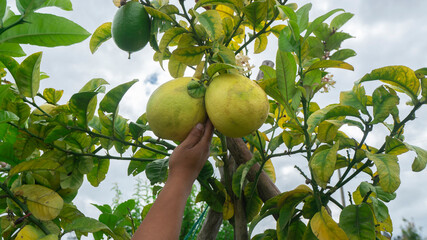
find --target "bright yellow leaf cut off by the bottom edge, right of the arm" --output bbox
[310,206,348,240]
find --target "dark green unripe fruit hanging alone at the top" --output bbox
[111,1,151,53]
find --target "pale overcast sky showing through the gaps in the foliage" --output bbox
[8,0,427,237]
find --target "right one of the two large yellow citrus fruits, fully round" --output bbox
[205,74,269,137]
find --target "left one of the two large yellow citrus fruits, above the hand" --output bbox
[146,77,207,141]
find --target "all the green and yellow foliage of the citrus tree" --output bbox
[0,0,427,240]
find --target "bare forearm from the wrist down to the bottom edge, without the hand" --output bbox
[132,176,194,240]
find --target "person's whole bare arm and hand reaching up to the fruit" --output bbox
[132,120,213,240]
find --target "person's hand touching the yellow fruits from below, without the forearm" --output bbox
[168,120,214,184]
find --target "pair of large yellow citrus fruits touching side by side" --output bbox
[146,74,269,141]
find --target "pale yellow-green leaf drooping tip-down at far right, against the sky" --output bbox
[365,151,400,193]
